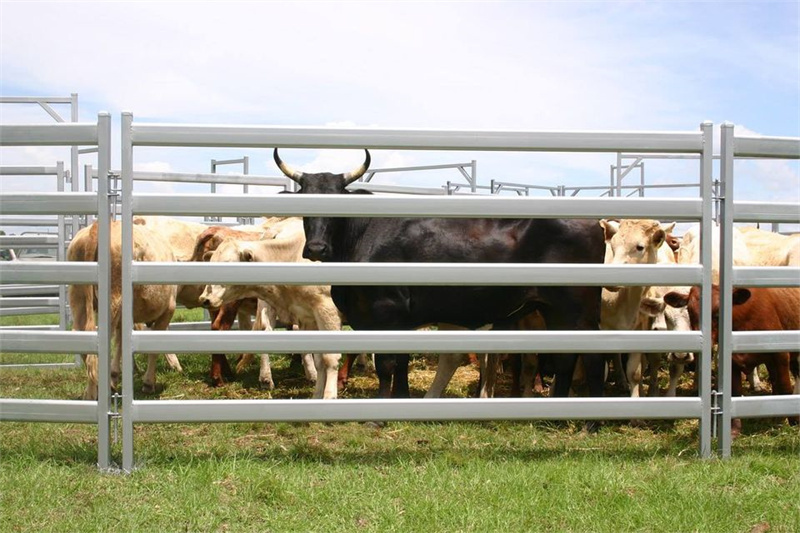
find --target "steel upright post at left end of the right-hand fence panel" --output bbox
[717,123,741,458]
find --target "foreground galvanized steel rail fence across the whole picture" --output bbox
[0,113,800,470]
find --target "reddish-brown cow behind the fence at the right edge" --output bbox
[664,285,800,435]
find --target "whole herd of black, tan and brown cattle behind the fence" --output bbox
[67,149,800,432]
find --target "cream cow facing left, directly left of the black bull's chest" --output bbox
[201,238,342,399]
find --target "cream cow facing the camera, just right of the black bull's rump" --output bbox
[600,219,675,397]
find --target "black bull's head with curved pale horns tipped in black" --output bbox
[273,148,370,261]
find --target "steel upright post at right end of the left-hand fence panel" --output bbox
[95,113,112,469]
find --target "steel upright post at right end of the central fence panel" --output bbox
[697,122,714,458]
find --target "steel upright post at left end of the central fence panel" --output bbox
[119,112,133,472]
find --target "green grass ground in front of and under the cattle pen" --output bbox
[0,315,800,533]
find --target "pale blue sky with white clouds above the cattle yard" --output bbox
[0,0,800,218]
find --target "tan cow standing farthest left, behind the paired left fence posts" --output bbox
[67,221,177,400]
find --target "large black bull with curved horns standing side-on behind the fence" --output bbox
[274,148,605,398]
